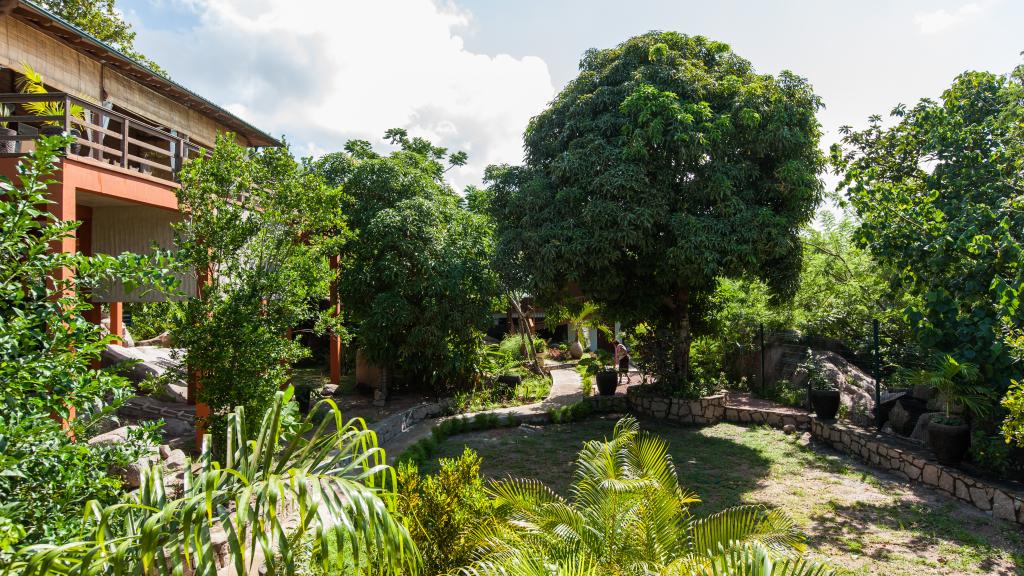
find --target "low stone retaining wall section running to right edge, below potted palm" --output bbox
[811,419,1024,524]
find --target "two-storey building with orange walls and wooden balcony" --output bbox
[0,0,296,412]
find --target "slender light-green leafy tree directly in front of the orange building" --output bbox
[173,135,344,445]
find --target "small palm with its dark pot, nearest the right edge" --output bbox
[911,355,988,465]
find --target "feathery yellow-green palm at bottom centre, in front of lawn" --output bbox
[463,417,831,576]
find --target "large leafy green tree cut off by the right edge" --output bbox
[834,67,1024,430]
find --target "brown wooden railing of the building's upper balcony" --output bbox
[0,92,206,181]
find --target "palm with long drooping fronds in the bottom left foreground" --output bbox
[5,393,419,576]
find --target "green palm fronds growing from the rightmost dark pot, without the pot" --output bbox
[909,355,990,423]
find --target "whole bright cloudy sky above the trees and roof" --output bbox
[118,0,1024,190]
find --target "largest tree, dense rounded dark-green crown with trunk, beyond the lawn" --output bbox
[489,32,822,381]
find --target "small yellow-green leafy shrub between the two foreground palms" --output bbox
[397,448,494,574]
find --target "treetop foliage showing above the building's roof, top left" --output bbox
[38,0,167,76]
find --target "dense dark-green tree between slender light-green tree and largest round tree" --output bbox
[341,129,498,387]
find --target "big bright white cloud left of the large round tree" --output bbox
[139,0,554,189]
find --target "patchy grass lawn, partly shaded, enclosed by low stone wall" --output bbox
[419,418,1024,576]
